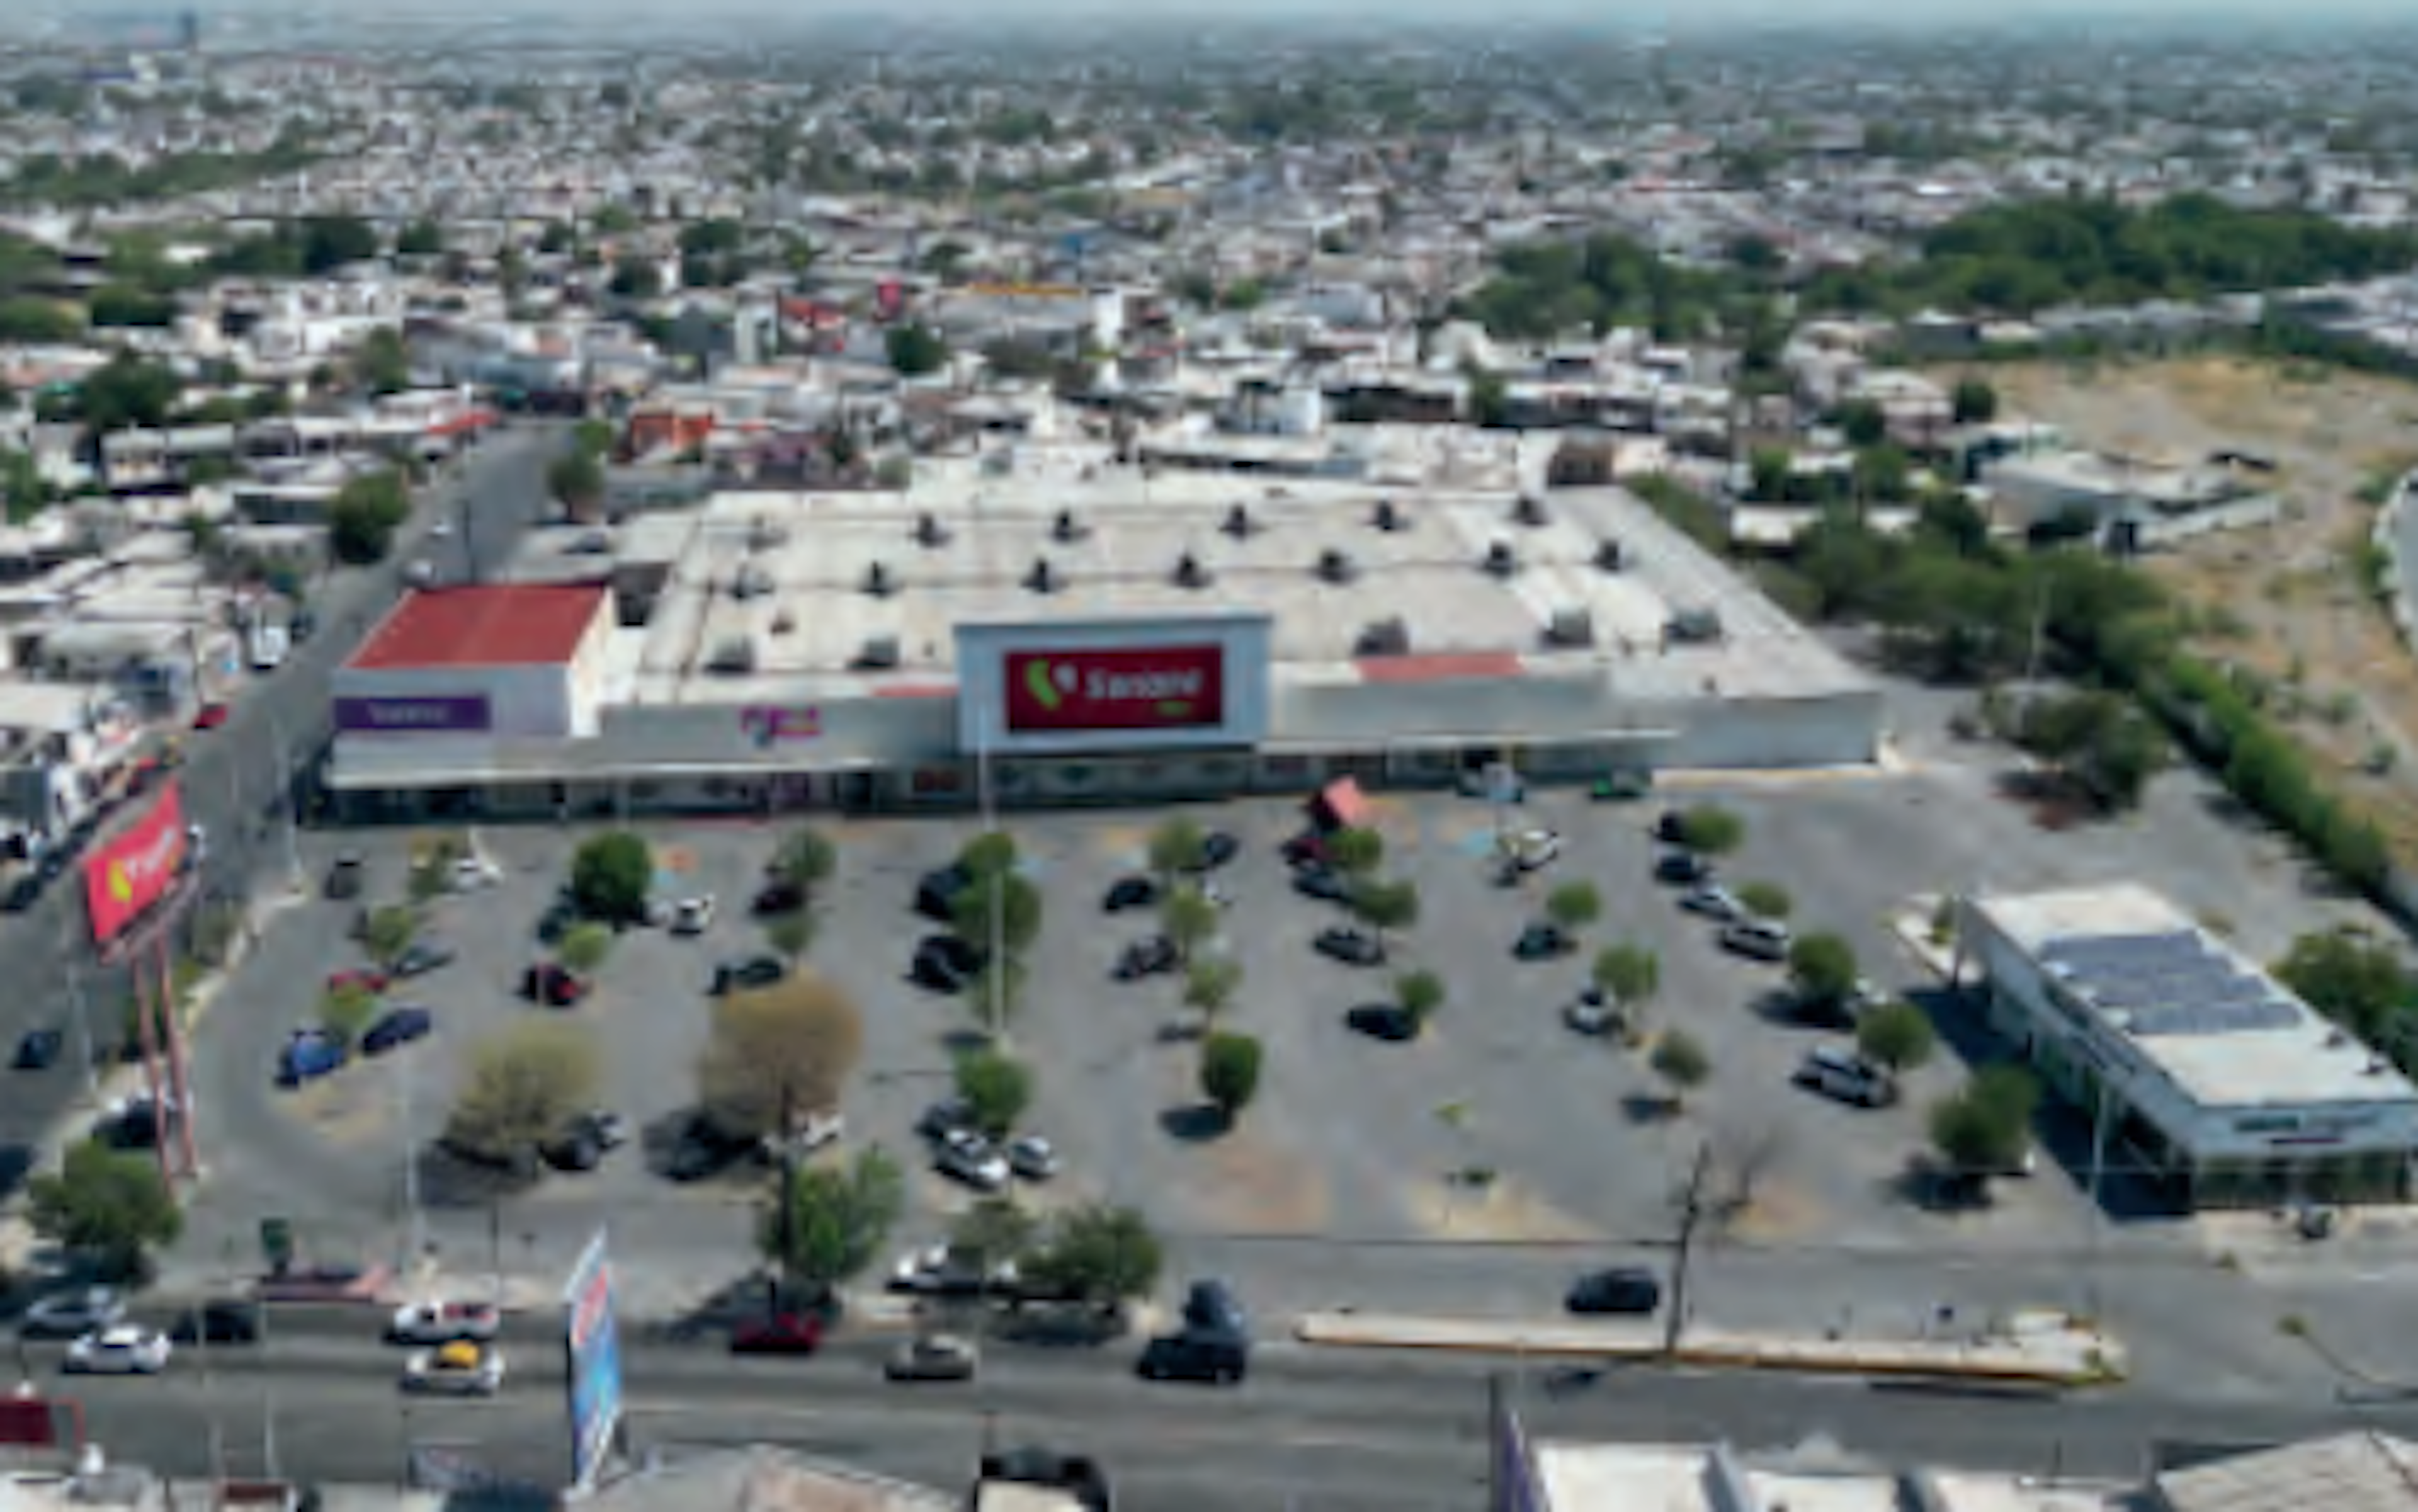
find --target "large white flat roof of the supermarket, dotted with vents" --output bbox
[594,467,1866,704]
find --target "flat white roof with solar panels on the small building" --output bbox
[1973,883,2418,1108]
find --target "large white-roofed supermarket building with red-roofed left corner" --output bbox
[326,462,1882,817]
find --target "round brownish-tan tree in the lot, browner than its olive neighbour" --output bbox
[696,972,866,1139]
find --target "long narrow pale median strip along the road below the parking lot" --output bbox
[1293,1311,2125,1386]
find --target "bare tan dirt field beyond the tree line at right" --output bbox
[1980,356,2418,863]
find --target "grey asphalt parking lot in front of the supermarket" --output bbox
[146,702,2336,1335]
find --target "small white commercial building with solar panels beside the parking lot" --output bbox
[1956,883,2418,1207]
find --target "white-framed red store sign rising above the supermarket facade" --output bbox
[958,610,1269,759]
